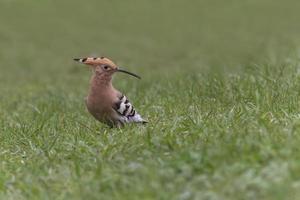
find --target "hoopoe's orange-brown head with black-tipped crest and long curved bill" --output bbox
[74,57,141,79]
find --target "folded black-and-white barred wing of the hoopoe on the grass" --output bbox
[113,94,147,123]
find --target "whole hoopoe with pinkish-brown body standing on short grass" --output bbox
[74,57,147,127]
